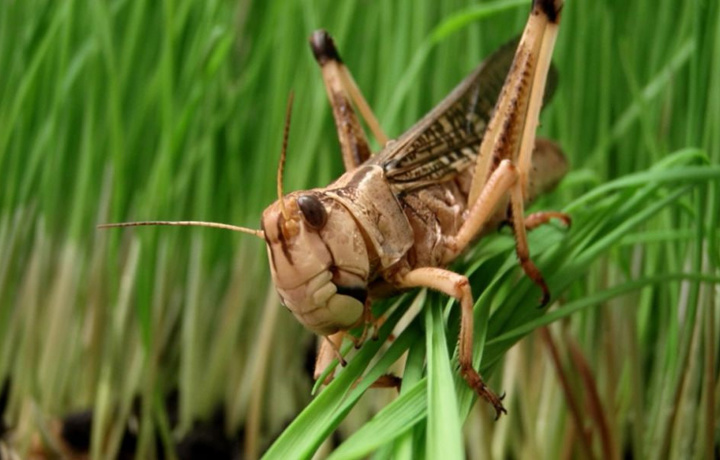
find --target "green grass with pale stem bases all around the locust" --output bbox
[0,0,720,458]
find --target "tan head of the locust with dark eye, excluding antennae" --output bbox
[262,191,369,335]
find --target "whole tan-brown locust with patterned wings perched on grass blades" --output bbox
[101,0,570,418]
